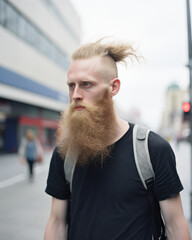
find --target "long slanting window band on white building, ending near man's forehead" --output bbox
[0,0,68,69]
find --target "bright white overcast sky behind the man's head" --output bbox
[71,0,189,130]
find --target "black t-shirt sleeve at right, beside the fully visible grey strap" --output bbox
[149,132,183,201]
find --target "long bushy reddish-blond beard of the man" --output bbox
[58,90,115,165]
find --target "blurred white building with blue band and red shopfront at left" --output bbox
[0,0,81,152]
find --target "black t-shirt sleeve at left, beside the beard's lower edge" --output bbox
[45,148,70,200]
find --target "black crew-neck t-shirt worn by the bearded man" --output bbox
[46,124,183,240]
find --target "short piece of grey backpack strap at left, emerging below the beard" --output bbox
[64,151,77,192]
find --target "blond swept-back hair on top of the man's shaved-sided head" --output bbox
[72,38,138,63]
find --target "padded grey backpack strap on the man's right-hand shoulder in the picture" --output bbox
[133,125,155,190]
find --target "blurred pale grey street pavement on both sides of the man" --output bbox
[0,142,192,240]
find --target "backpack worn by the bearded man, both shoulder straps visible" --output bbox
[64,125,167,240]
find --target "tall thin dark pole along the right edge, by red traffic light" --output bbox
[186,0,192,222]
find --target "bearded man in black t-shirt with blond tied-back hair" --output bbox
[44,40,191,240]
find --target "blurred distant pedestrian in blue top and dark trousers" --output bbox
[19,129,43,180]
